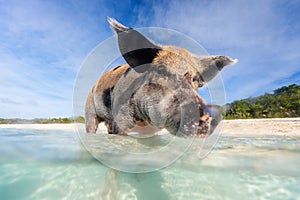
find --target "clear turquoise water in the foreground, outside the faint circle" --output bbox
[0,129,300,200]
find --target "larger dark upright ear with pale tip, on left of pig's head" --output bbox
[107,18,161,70]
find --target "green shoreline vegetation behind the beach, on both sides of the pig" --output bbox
[0,84,300,124]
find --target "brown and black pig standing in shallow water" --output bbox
[85,18,237,136]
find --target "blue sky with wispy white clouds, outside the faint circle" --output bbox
[0,0,300,118]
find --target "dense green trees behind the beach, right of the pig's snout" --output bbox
[225,84,300,119]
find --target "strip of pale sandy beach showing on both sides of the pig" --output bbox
[0,118,300,136]
